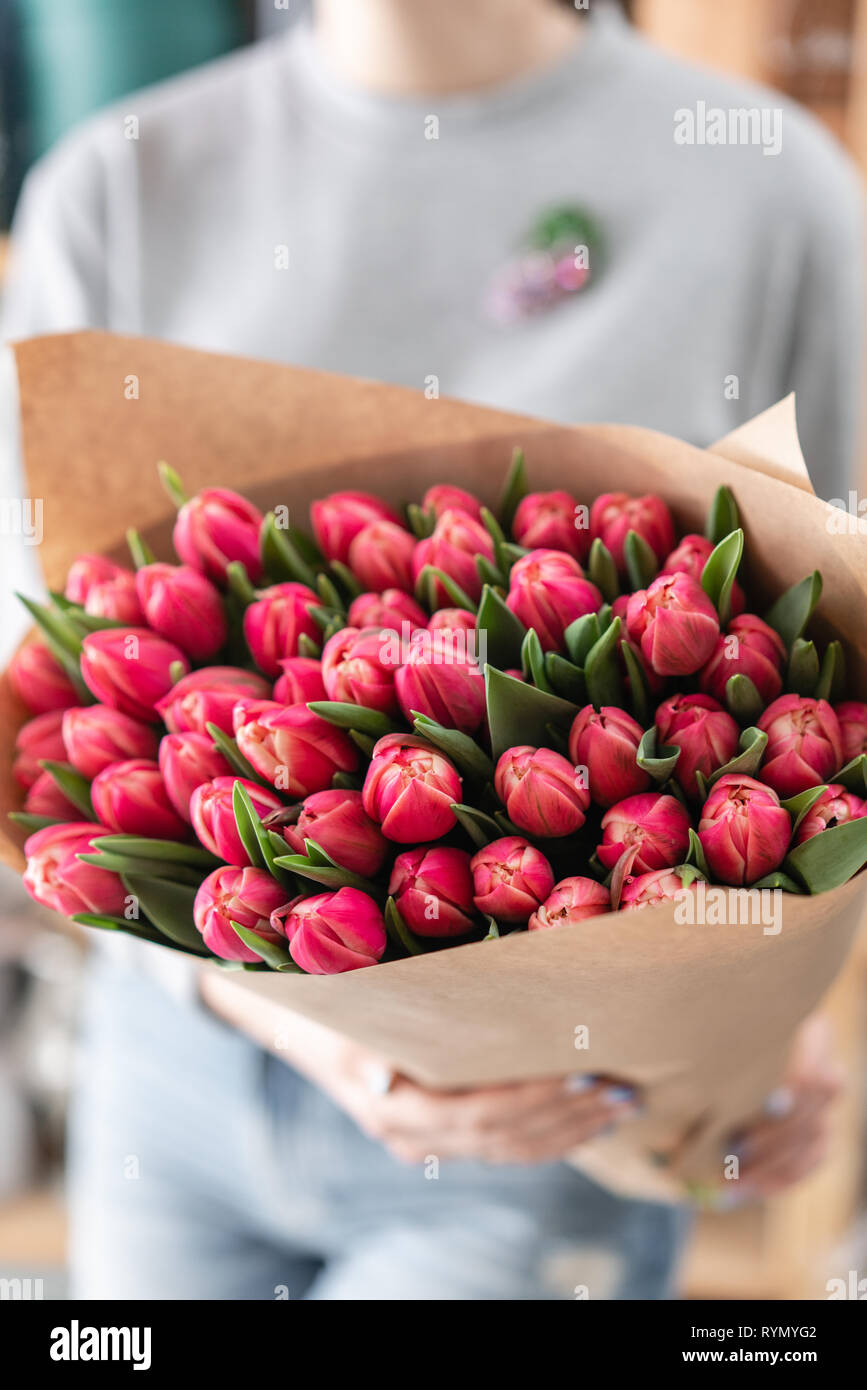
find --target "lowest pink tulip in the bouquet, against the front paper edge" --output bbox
[271,888,386,974]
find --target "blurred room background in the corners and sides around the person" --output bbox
[0,0,867,1298]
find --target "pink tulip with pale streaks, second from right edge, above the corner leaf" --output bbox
[759,695,843,796]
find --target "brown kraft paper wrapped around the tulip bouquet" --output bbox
[0,334,867,1200]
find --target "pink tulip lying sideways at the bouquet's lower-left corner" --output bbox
[24,820,126,917]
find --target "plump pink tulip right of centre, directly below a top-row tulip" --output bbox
[506,550,602,652]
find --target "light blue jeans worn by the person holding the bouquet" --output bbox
[69,962,688,1300]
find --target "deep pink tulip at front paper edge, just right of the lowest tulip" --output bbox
[389,845,475,937]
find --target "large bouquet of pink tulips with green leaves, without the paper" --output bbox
[10,455,867,974]
